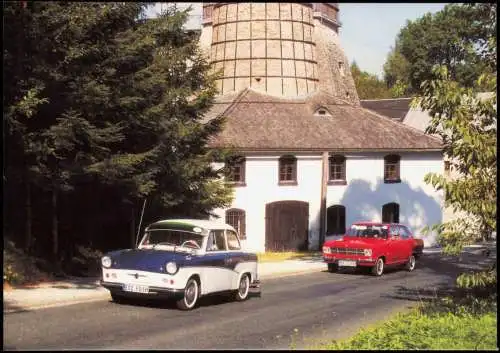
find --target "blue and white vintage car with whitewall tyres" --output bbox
[101,219,260,310]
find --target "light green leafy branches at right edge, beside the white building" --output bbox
[414,67,497,253]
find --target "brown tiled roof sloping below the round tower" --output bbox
[207,88,442,151]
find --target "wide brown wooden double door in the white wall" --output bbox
[266,201,309,251]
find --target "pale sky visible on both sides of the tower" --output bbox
[148,2,446,78]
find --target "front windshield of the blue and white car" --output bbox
[141,229,203,250]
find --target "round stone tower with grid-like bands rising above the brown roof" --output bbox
[200,3,359,105]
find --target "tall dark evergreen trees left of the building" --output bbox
[4,2,231,262]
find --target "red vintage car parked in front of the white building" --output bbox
[323,222,424,276]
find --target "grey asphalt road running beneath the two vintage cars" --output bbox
[4,255,494,350]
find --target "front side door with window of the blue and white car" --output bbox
[202,230,232,293]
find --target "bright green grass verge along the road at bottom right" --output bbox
[315,294,497,350]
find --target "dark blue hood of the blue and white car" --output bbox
[107,249,190,272]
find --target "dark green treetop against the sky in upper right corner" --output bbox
[384,3,496,94]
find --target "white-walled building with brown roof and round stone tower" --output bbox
[200,3,443,251]
